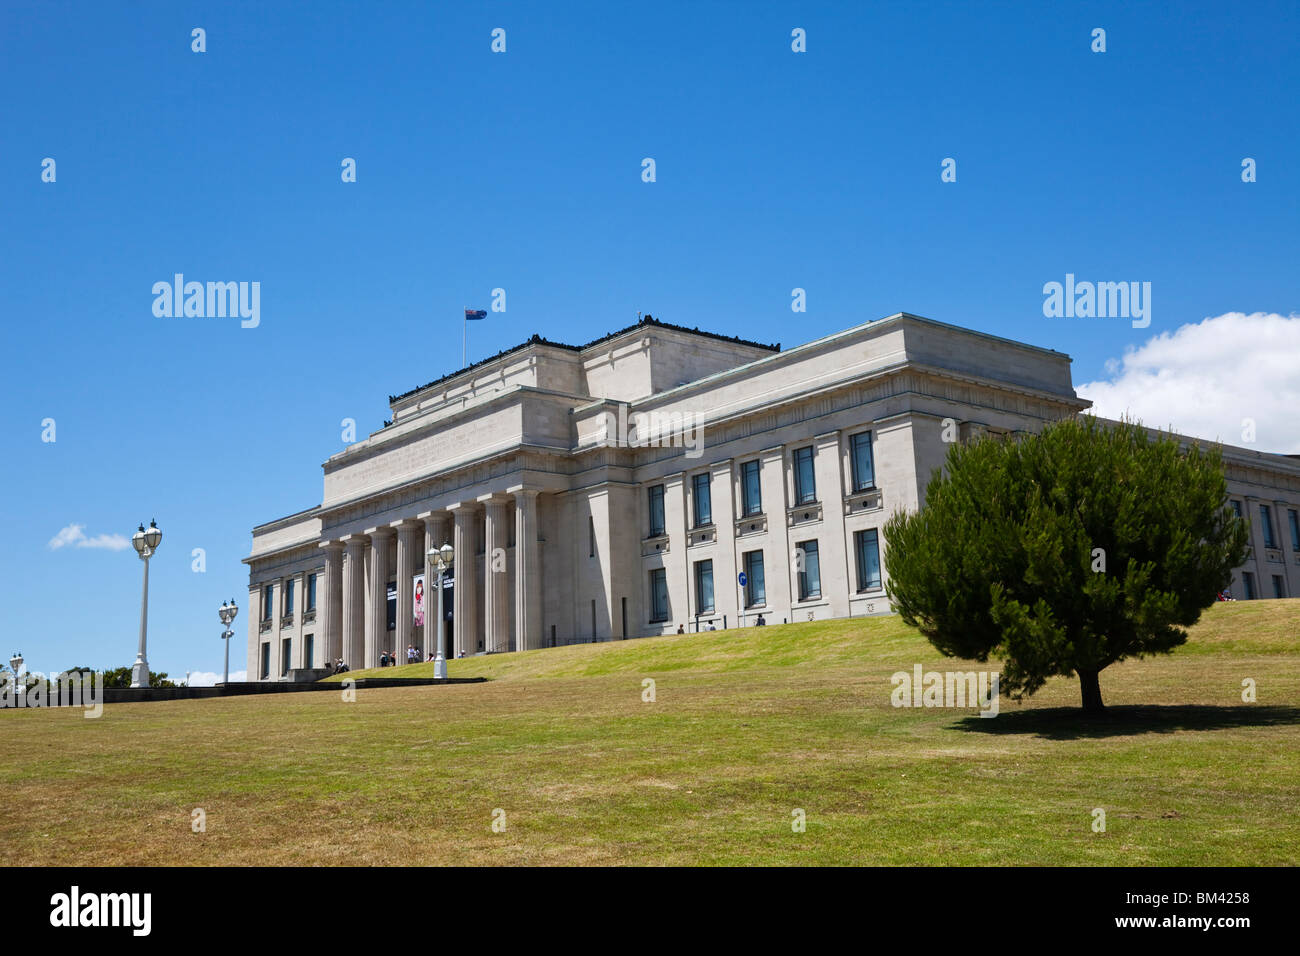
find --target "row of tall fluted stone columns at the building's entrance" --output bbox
[321,486,542,670]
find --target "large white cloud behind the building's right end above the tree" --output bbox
[1076,312,1300,454]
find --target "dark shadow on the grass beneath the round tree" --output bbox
[956,701,1300,740]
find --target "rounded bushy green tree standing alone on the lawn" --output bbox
[884,416,1249,713]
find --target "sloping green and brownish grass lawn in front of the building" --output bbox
[0,601,1300,865]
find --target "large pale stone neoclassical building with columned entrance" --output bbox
[246,313,1300,680]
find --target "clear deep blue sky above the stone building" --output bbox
[0,0,1300,676]
